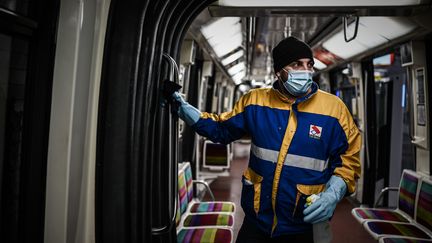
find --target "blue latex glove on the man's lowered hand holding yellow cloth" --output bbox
[303,175,347,224]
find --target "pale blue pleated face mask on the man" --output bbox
[283,69,313,97]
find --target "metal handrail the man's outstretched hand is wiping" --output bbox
[152,53,179,235]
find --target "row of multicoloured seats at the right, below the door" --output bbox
[351,170,432,243]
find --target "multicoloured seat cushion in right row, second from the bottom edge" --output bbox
[364,221,430,239]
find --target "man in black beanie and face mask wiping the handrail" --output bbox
[169,37,361,242]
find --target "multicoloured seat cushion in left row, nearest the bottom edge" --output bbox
[177,228,233,243]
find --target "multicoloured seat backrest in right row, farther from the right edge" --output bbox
[398,170,420,218]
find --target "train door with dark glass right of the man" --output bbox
[363,45,424,206]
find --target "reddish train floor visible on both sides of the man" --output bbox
[204,143,376,243]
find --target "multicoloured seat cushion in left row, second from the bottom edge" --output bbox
[183,214,234,227]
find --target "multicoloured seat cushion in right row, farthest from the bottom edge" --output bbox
[352,208,409,223]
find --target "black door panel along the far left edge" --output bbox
[0,0,59,242]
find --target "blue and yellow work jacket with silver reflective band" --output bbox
[192,82,361,237]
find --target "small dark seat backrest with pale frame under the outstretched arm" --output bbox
[203,140,230,169]
